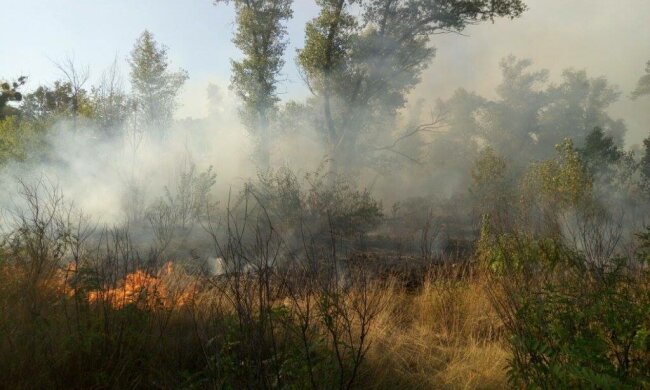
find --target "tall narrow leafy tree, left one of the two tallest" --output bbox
[215,0,293,169]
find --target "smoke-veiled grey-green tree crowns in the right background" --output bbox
[431,56,626,171]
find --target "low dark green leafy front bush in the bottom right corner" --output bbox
[498,258,650,389]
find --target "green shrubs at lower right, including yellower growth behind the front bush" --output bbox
[478,221,650,389]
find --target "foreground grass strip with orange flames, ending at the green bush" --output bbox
[0,254,508,389]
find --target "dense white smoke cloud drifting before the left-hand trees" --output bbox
[0,84,255,225]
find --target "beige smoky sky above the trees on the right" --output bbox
[411,0,650,146]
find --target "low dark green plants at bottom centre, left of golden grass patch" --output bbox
[183,307,338,390]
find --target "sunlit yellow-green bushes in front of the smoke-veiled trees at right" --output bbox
[470,139,599,244]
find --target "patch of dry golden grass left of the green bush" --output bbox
[364,275,508,389]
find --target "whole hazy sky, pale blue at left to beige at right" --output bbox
[0,0,650,144]
